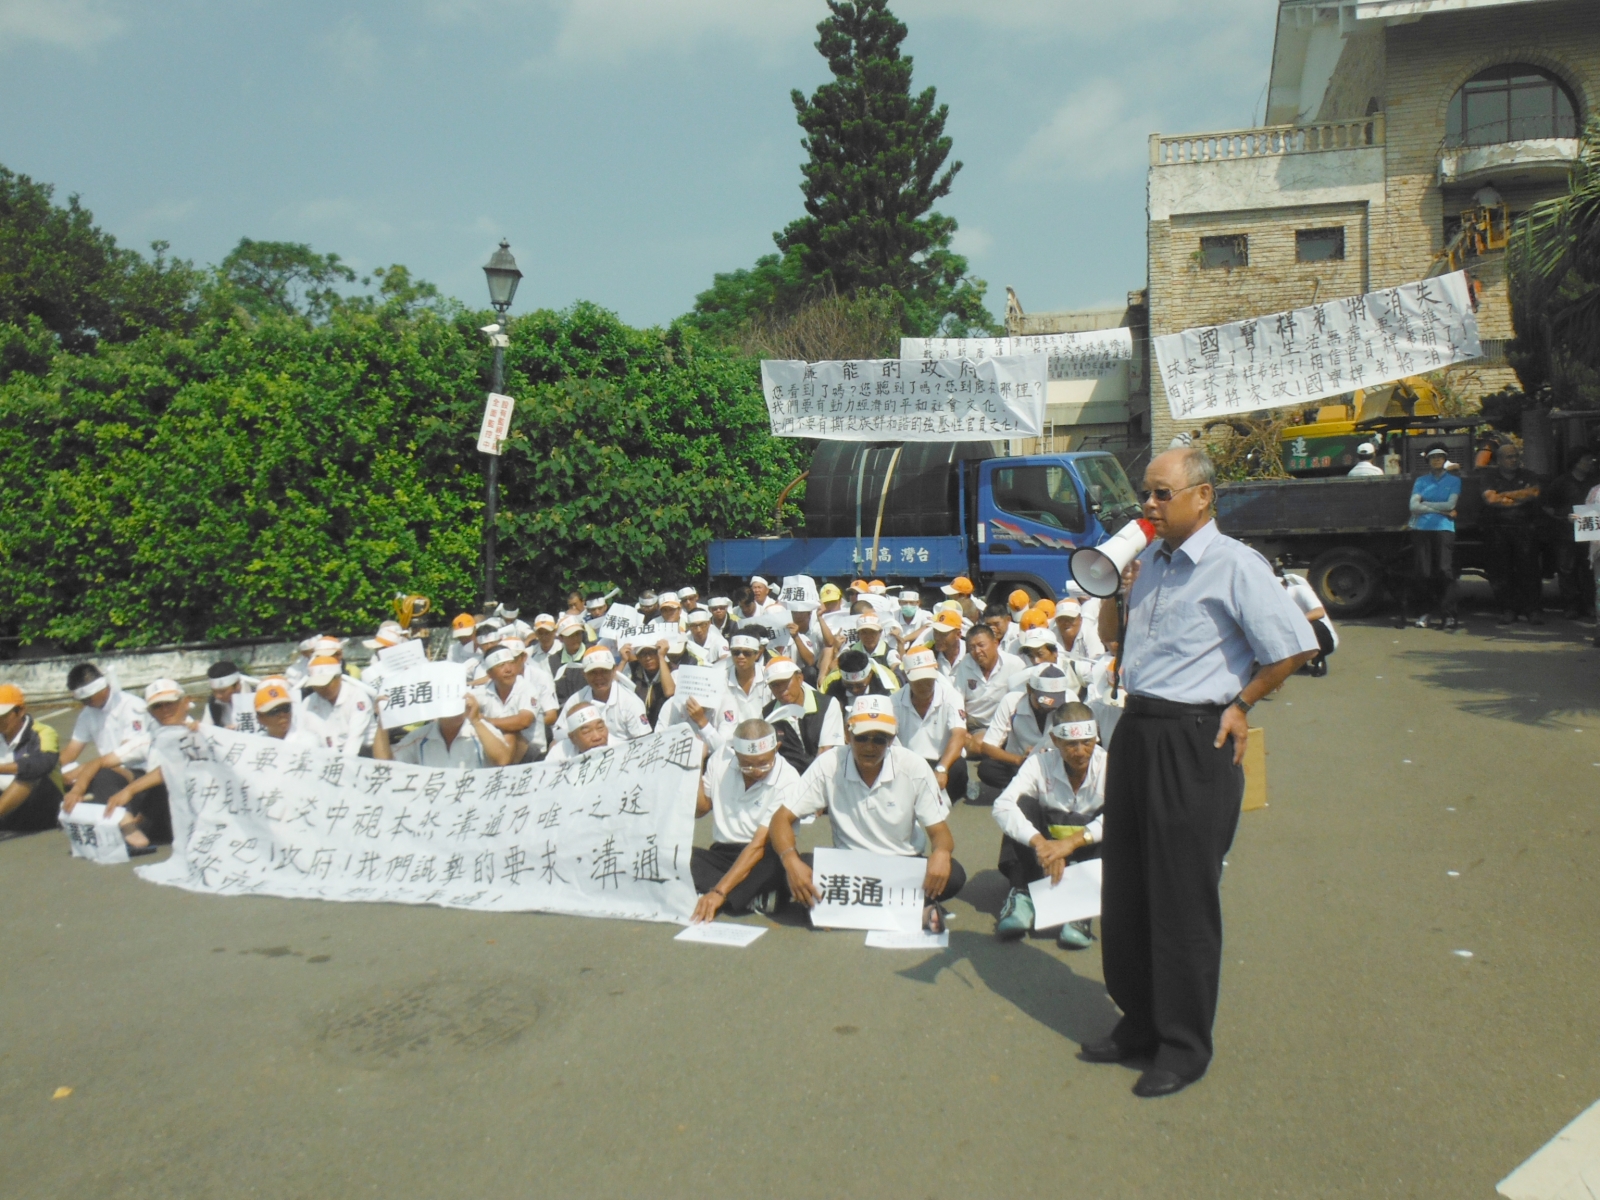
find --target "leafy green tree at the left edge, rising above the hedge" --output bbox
[0,166,200,352]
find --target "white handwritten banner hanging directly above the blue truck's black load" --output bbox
[762,355,1046,442]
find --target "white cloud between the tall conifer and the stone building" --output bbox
[1011,78,1160,179]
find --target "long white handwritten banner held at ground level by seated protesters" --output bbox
[139,725,699,925]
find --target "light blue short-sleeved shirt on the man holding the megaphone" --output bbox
[1122,520,1317,704]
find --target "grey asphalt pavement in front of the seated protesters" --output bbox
[0,618,1600,1200]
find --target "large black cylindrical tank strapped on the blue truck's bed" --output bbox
[805,442,997,538]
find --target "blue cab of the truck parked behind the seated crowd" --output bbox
[973,451,1139,595]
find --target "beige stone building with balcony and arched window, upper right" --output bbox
[1147,0,1600,451]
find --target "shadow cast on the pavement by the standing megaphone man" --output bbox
[896,930,1117,1042]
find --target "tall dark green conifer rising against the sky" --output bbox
[691,0,994,341]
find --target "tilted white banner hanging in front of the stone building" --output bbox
[1155,270,1483,421]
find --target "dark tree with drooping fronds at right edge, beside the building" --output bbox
[1507,118,1600,408]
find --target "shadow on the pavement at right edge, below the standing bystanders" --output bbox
[1395,649,1600,725]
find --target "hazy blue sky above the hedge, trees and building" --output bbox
[0,0,1275,325]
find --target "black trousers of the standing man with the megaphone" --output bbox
[1101,696,1245,1078]
